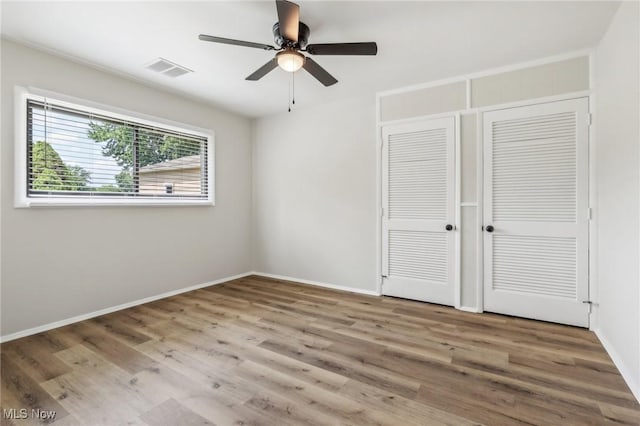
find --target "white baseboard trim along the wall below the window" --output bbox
[0,272,253,343]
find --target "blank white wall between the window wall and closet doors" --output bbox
[253,95,377,291]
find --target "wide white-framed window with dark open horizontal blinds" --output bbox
[16,87,213,207]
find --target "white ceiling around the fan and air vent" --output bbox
[1,1,619,117]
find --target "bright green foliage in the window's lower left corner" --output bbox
[31,141,91,191]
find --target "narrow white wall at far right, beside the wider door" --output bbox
[594,2,640,399]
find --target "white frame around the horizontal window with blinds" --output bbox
[14,86,215,208]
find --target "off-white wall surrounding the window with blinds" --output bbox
[1,40,251,336]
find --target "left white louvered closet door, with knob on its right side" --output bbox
[382,117,455,305]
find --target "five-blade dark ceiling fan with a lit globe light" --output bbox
[198,0,378,86]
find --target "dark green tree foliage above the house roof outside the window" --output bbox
[88,123,200,171]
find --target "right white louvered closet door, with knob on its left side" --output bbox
[483,98,589,327]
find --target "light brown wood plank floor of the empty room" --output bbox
[0,277,640,426]
